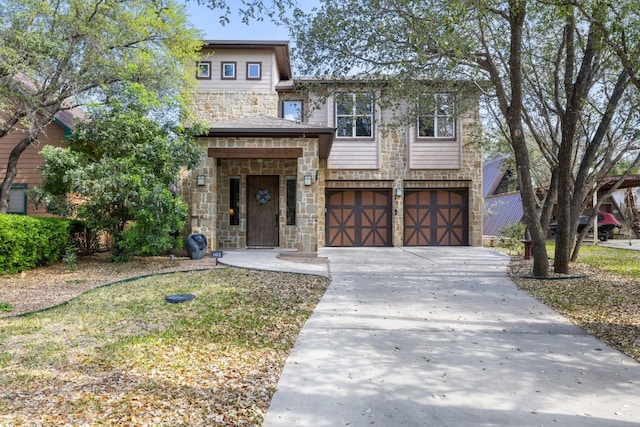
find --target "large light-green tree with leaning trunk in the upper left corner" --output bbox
[0,0,201,213]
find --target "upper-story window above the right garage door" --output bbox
[418,94,456,139]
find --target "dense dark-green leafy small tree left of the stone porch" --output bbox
[34,85,201,260]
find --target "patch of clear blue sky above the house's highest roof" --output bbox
[187,0,296,40]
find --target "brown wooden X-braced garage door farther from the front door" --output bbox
[404,189,469,246]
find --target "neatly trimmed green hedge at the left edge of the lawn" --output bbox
[0,215,70,274]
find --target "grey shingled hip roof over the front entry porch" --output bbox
[203,116,336,159]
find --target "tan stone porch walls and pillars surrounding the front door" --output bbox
[191,138,320,252]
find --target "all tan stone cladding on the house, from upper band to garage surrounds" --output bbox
[188,91,483,252]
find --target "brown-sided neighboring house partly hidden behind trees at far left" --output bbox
[0,110,80,216]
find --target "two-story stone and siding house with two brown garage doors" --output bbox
[188,41,483,253]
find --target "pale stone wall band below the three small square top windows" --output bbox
[195,91,279,123]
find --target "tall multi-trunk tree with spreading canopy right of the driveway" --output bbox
[292,0,635,276]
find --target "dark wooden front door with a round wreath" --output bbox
[247,175,280,247]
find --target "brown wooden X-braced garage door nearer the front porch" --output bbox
[325,190,391,247]
